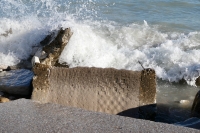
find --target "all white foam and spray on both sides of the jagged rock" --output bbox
[0,0,200,85]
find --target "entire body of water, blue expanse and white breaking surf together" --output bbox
[0,0,200,123]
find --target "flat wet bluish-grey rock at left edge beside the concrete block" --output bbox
[0,69,34,95]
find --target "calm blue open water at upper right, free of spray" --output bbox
[94,0,200,32]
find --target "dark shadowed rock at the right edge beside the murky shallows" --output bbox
[191,91,200,118]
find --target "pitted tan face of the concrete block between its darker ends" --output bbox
[32,67,141,114]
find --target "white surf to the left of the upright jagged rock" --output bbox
[0,17,45,65]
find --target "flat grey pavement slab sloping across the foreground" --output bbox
[0,99,199,133]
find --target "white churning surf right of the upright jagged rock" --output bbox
[60,21,200,85]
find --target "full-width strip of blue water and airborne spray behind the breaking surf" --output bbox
[0,0,200,32]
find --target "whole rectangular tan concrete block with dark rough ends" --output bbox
[32,64,156,117]
